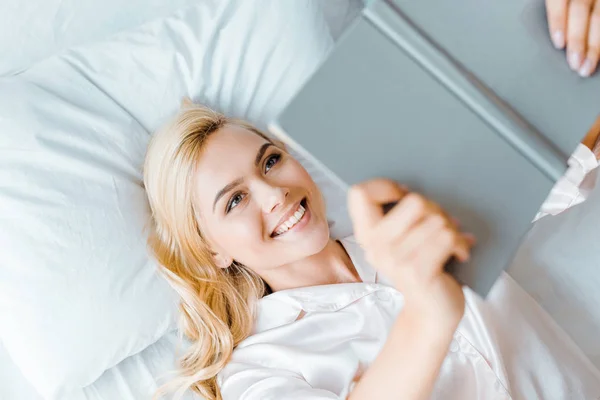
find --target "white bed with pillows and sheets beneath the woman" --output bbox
[0,0,600,400]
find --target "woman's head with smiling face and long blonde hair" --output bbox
[144,104,336,398]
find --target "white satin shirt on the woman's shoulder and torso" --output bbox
[218,238,600,400]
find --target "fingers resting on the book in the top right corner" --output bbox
[546,0,600,77]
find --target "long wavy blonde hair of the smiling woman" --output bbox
[144,101,270,400]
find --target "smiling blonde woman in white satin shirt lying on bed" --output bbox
[144,105,600,400]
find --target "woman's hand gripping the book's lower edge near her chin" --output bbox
[348,179,473,325]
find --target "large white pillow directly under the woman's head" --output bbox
[0,0,343,399]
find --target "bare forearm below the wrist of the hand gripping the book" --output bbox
[348,307,458,400]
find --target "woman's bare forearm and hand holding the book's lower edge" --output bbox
[348,179,473,400]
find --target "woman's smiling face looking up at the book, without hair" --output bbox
[195,125,329,275]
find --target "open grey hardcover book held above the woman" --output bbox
[270,0,600,296]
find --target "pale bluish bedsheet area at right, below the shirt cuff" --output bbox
[508,169,600,368]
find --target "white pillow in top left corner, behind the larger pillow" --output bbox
[0,0,197,76]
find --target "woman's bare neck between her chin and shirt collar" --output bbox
[262,239,361,292]
